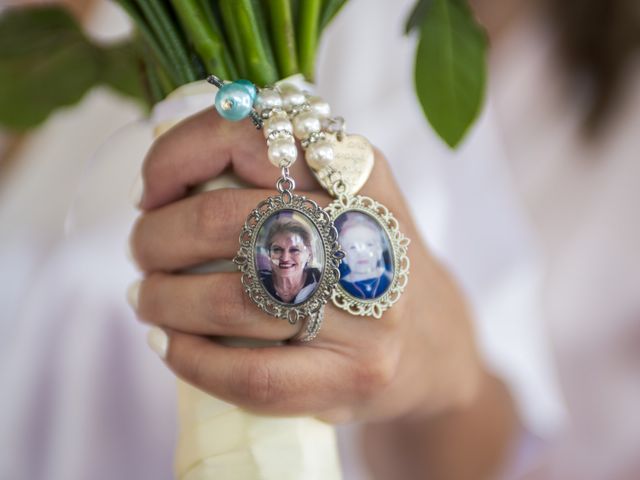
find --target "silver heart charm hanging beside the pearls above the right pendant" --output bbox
[312,135,374,196]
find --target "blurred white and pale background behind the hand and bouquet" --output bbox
[0,0,640,480]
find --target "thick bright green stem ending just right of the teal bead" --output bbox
[221,0,278,86]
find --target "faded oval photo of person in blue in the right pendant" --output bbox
[335,212,393,300]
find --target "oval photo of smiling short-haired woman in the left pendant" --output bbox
[256,210,324,305]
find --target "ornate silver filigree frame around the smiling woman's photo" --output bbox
[233,190,343,326]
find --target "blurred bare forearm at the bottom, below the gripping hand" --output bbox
[362,374,519,480]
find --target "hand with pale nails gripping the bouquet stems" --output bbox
[131,109,482,422]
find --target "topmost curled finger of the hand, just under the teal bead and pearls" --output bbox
[140,108,318,210]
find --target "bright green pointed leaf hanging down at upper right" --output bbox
[414,0,487,147]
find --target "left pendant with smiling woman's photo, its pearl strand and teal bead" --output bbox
[208,76,344,342]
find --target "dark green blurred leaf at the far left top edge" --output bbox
[0,7,101,130]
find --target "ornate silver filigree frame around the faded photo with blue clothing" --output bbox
[325,195,410,318]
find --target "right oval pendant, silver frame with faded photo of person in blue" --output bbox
[326,195,410,318]
